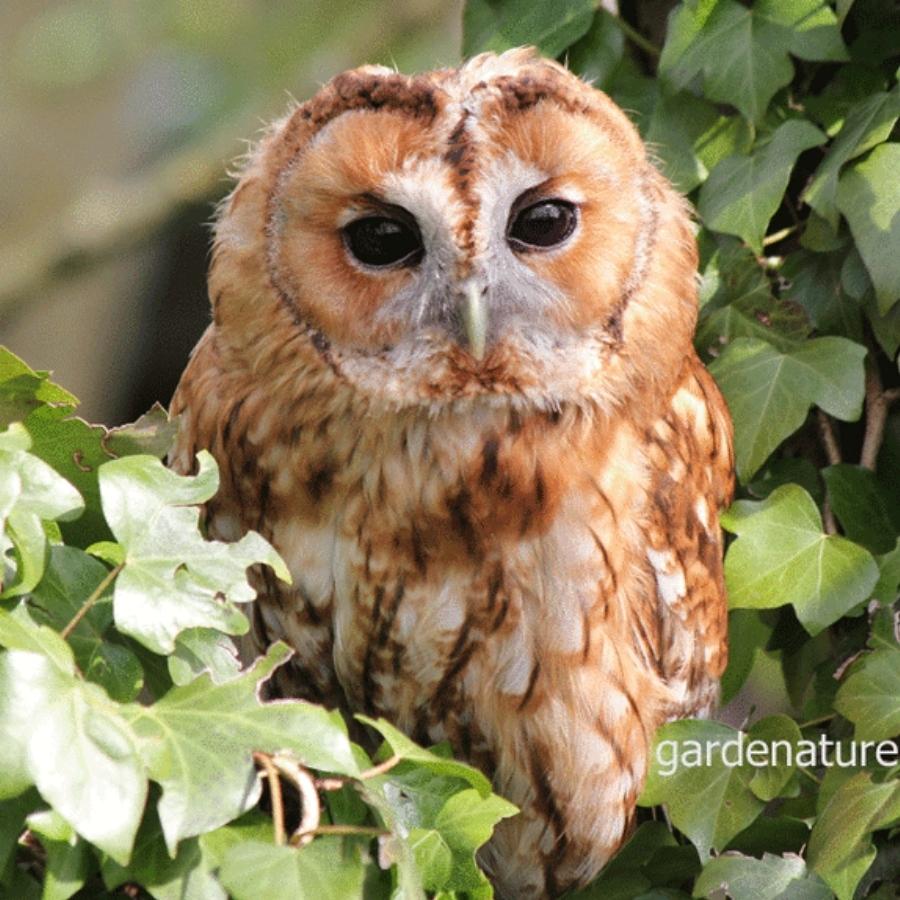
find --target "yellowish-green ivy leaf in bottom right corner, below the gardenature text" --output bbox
[807,772,900,900]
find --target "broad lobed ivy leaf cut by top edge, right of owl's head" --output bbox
[659,0,847,121]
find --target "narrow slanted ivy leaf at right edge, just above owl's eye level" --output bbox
[801,87,900,229]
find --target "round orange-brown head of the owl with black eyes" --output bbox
[210,49,696,410]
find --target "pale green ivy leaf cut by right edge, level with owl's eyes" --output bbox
[837,144,900,315]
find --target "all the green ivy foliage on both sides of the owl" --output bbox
[0,0,900,900]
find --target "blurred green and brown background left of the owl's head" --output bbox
[0,0,462,424]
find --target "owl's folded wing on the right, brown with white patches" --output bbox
[646,357,734,717]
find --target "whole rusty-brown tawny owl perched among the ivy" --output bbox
[174,50,732,898]
